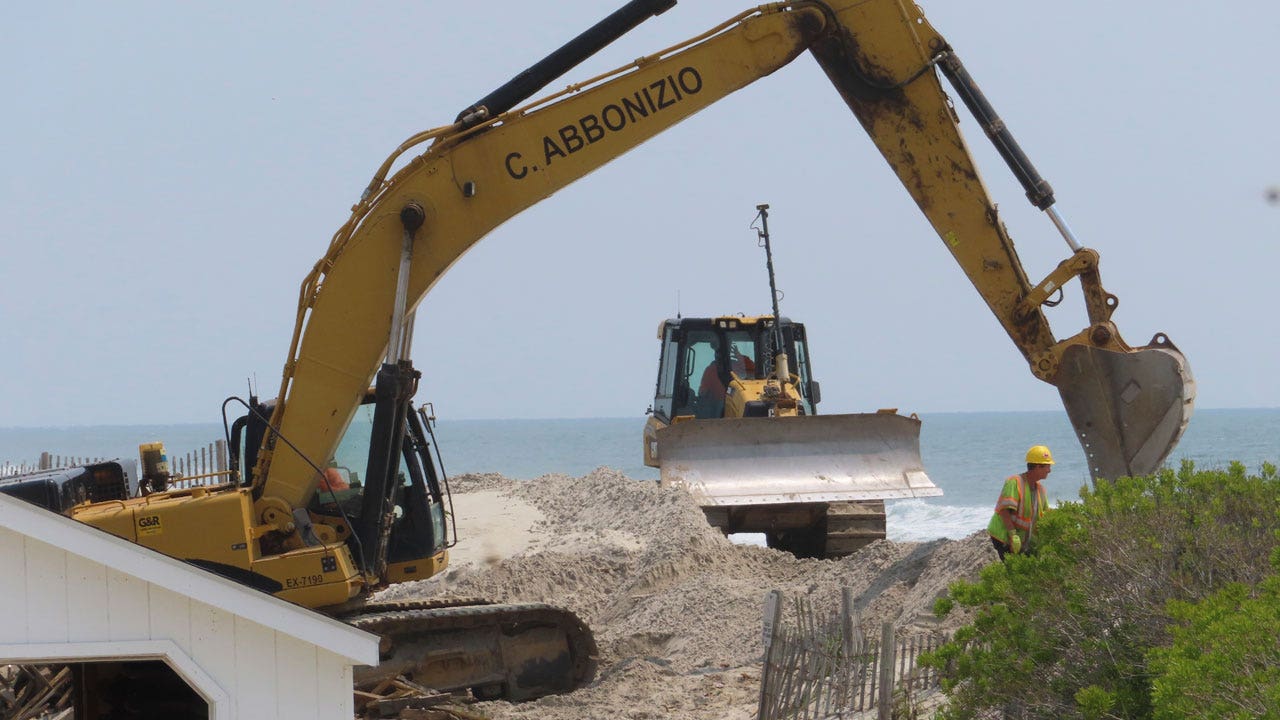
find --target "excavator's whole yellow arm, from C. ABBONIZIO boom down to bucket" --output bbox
[255,0,1193,507]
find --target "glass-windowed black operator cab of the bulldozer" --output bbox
[653,316,819,423]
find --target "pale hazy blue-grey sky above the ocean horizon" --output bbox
[0,0,1280,427]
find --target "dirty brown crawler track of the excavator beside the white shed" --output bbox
[334,598,599,702]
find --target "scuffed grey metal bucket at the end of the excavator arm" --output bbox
[1055,334,1196,482]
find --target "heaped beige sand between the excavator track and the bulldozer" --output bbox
[373,468,995,720]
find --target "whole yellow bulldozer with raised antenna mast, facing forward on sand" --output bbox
[644,204,942,559]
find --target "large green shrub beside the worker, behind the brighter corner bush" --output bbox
[927,462,1280,720]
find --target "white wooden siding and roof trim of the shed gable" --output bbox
[0,496,378,720]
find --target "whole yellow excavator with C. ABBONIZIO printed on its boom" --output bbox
[40,0,1193,700]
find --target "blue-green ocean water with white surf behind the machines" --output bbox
[0,409,1280,541]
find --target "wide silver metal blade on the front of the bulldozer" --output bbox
[657,413,942,507]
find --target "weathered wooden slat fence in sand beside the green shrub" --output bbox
[758,591,946,720]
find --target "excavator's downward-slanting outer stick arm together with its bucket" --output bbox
[812,1,1196,479]
